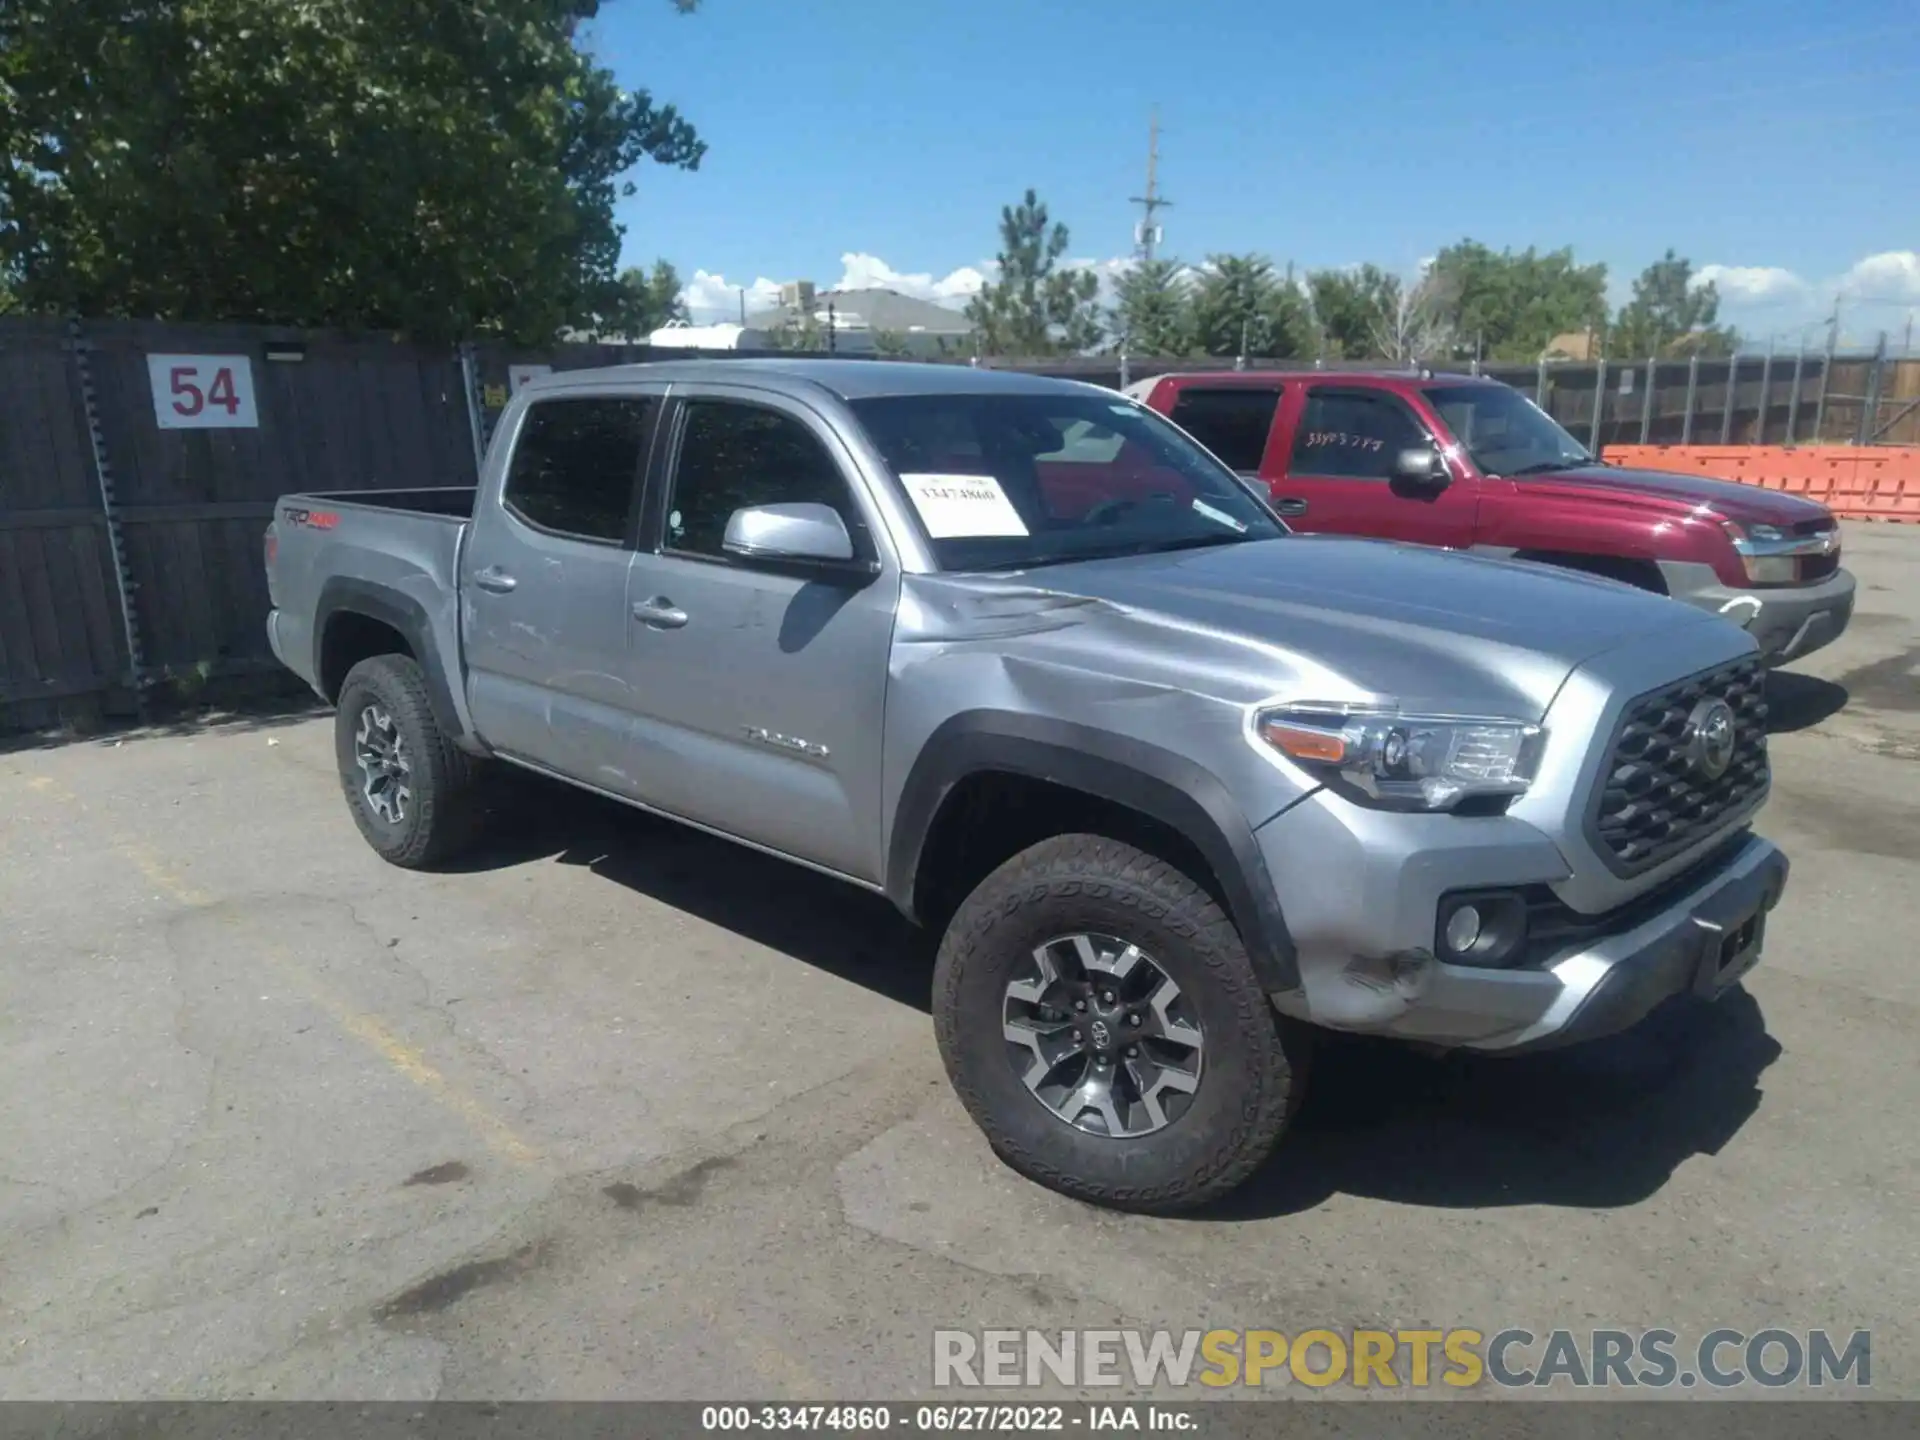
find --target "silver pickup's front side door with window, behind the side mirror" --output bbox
[626,382,900,881]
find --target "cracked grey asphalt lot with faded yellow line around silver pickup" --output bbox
[0,526,1920,1400]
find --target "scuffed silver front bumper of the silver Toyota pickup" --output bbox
[1260,801,1788,1052]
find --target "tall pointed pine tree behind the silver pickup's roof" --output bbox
[966,190,1100,355]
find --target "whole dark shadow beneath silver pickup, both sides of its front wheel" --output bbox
[449,778,1780,1223]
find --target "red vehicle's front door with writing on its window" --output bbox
[1269,382,1478,549]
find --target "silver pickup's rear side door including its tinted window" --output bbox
[459,384,664,795]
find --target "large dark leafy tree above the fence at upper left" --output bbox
[0,0,705,340]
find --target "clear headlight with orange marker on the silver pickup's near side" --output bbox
[1254,703,1546,810]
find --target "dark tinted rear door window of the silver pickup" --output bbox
[501,396,657,545]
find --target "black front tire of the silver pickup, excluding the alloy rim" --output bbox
[933,835,1304,1213]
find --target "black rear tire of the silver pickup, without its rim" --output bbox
[334,655,482,870]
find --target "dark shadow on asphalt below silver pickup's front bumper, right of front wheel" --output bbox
[1196,987,1780,1221]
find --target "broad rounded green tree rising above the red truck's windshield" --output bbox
[1427,240,1607,359]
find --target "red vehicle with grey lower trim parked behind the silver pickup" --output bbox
[1127,371,1853,664]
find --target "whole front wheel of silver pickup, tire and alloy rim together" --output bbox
[933,835,1296,1213]
